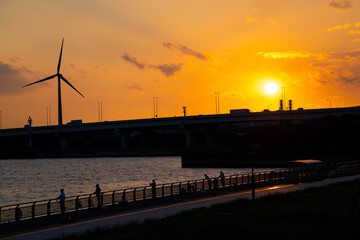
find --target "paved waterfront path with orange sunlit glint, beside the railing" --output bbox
[4,174,360,240]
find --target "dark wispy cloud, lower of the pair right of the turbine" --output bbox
[122,52,183,77]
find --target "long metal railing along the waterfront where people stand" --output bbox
[0,162,360,224]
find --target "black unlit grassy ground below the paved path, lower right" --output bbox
[54,180,360,240]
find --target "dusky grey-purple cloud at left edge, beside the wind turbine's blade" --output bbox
[0,61,34,94]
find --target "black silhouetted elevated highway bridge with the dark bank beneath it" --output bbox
[0,107,360,167]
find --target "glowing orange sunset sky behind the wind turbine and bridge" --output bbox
[0,0,360,128]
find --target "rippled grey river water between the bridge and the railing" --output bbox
[0,157,278,206]
